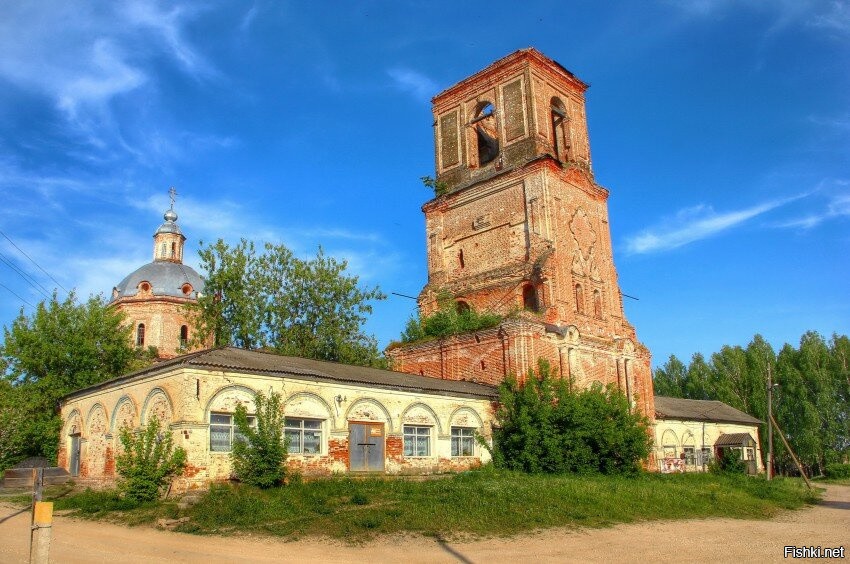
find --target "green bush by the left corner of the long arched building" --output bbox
[115,417,186,503]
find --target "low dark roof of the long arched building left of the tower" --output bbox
[63,347,498,400]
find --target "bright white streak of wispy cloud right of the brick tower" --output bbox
[626,195,804,254]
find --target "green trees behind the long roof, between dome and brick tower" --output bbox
[188,239,385,365]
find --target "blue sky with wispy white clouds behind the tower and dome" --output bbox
[0,0,850,366]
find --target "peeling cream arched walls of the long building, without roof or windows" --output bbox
[59,368,492,492]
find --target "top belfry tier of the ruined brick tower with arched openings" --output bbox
[432,48,591,198]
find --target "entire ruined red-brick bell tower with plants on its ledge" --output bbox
[387,49,653,417]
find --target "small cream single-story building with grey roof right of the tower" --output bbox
[653,396,764,474]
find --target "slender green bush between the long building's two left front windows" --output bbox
[230,392,286,488]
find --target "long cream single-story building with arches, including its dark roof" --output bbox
[59,347,497,492]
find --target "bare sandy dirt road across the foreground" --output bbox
[0,486,850,564]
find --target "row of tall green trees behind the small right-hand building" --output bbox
[654,331,850,474]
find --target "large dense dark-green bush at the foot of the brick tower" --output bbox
[493,361,651,474]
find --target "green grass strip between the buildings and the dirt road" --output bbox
[34,470,817,541]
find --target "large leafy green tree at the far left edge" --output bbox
[0,292,155,464]
